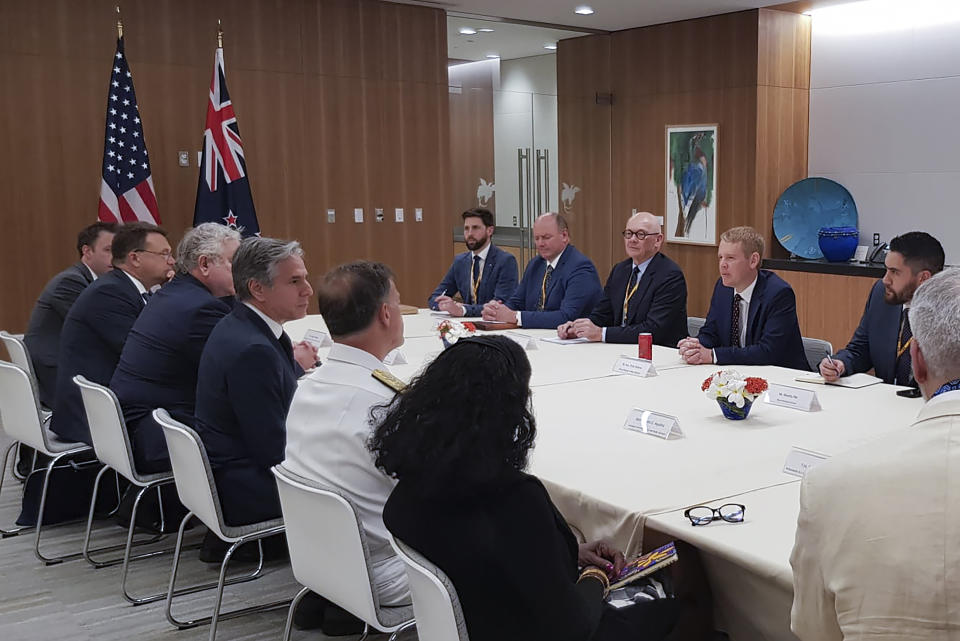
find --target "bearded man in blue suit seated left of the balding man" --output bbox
[427,208,517,316]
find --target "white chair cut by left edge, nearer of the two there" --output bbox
[0,361,99,565]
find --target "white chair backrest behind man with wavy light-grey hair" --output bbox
[73,374,139,485]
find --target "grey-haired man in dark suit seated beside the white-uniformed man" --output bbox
[195,237,316,540]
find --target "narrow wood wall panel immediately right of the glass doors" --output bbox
[557,35,619,278]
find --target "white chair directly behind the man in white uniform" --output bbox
[273,465,415,641]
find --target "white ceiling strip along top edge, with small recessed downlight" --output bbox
[395,0,786,31]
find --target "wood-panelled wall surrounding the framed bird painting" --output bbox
[557,9,810,316]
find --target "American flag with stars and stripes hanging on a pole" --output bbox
[99,37,160,225]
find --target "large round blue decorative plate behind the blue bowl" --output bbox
[773,178,857,258]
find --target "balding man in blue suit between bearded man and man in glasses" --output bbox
[483,212,603,329]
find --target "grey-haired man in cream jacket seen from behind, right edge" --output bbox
[790,269,960,641]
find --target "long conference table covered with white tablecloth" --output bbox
[286,310,923,641]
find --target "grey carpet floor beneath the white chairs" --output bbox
[0,433,416,641]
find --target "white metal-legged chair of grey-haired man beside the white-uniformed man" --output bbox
[153,409,290,641]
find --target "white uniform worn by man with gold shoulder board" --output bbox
[283,343,410,605]
